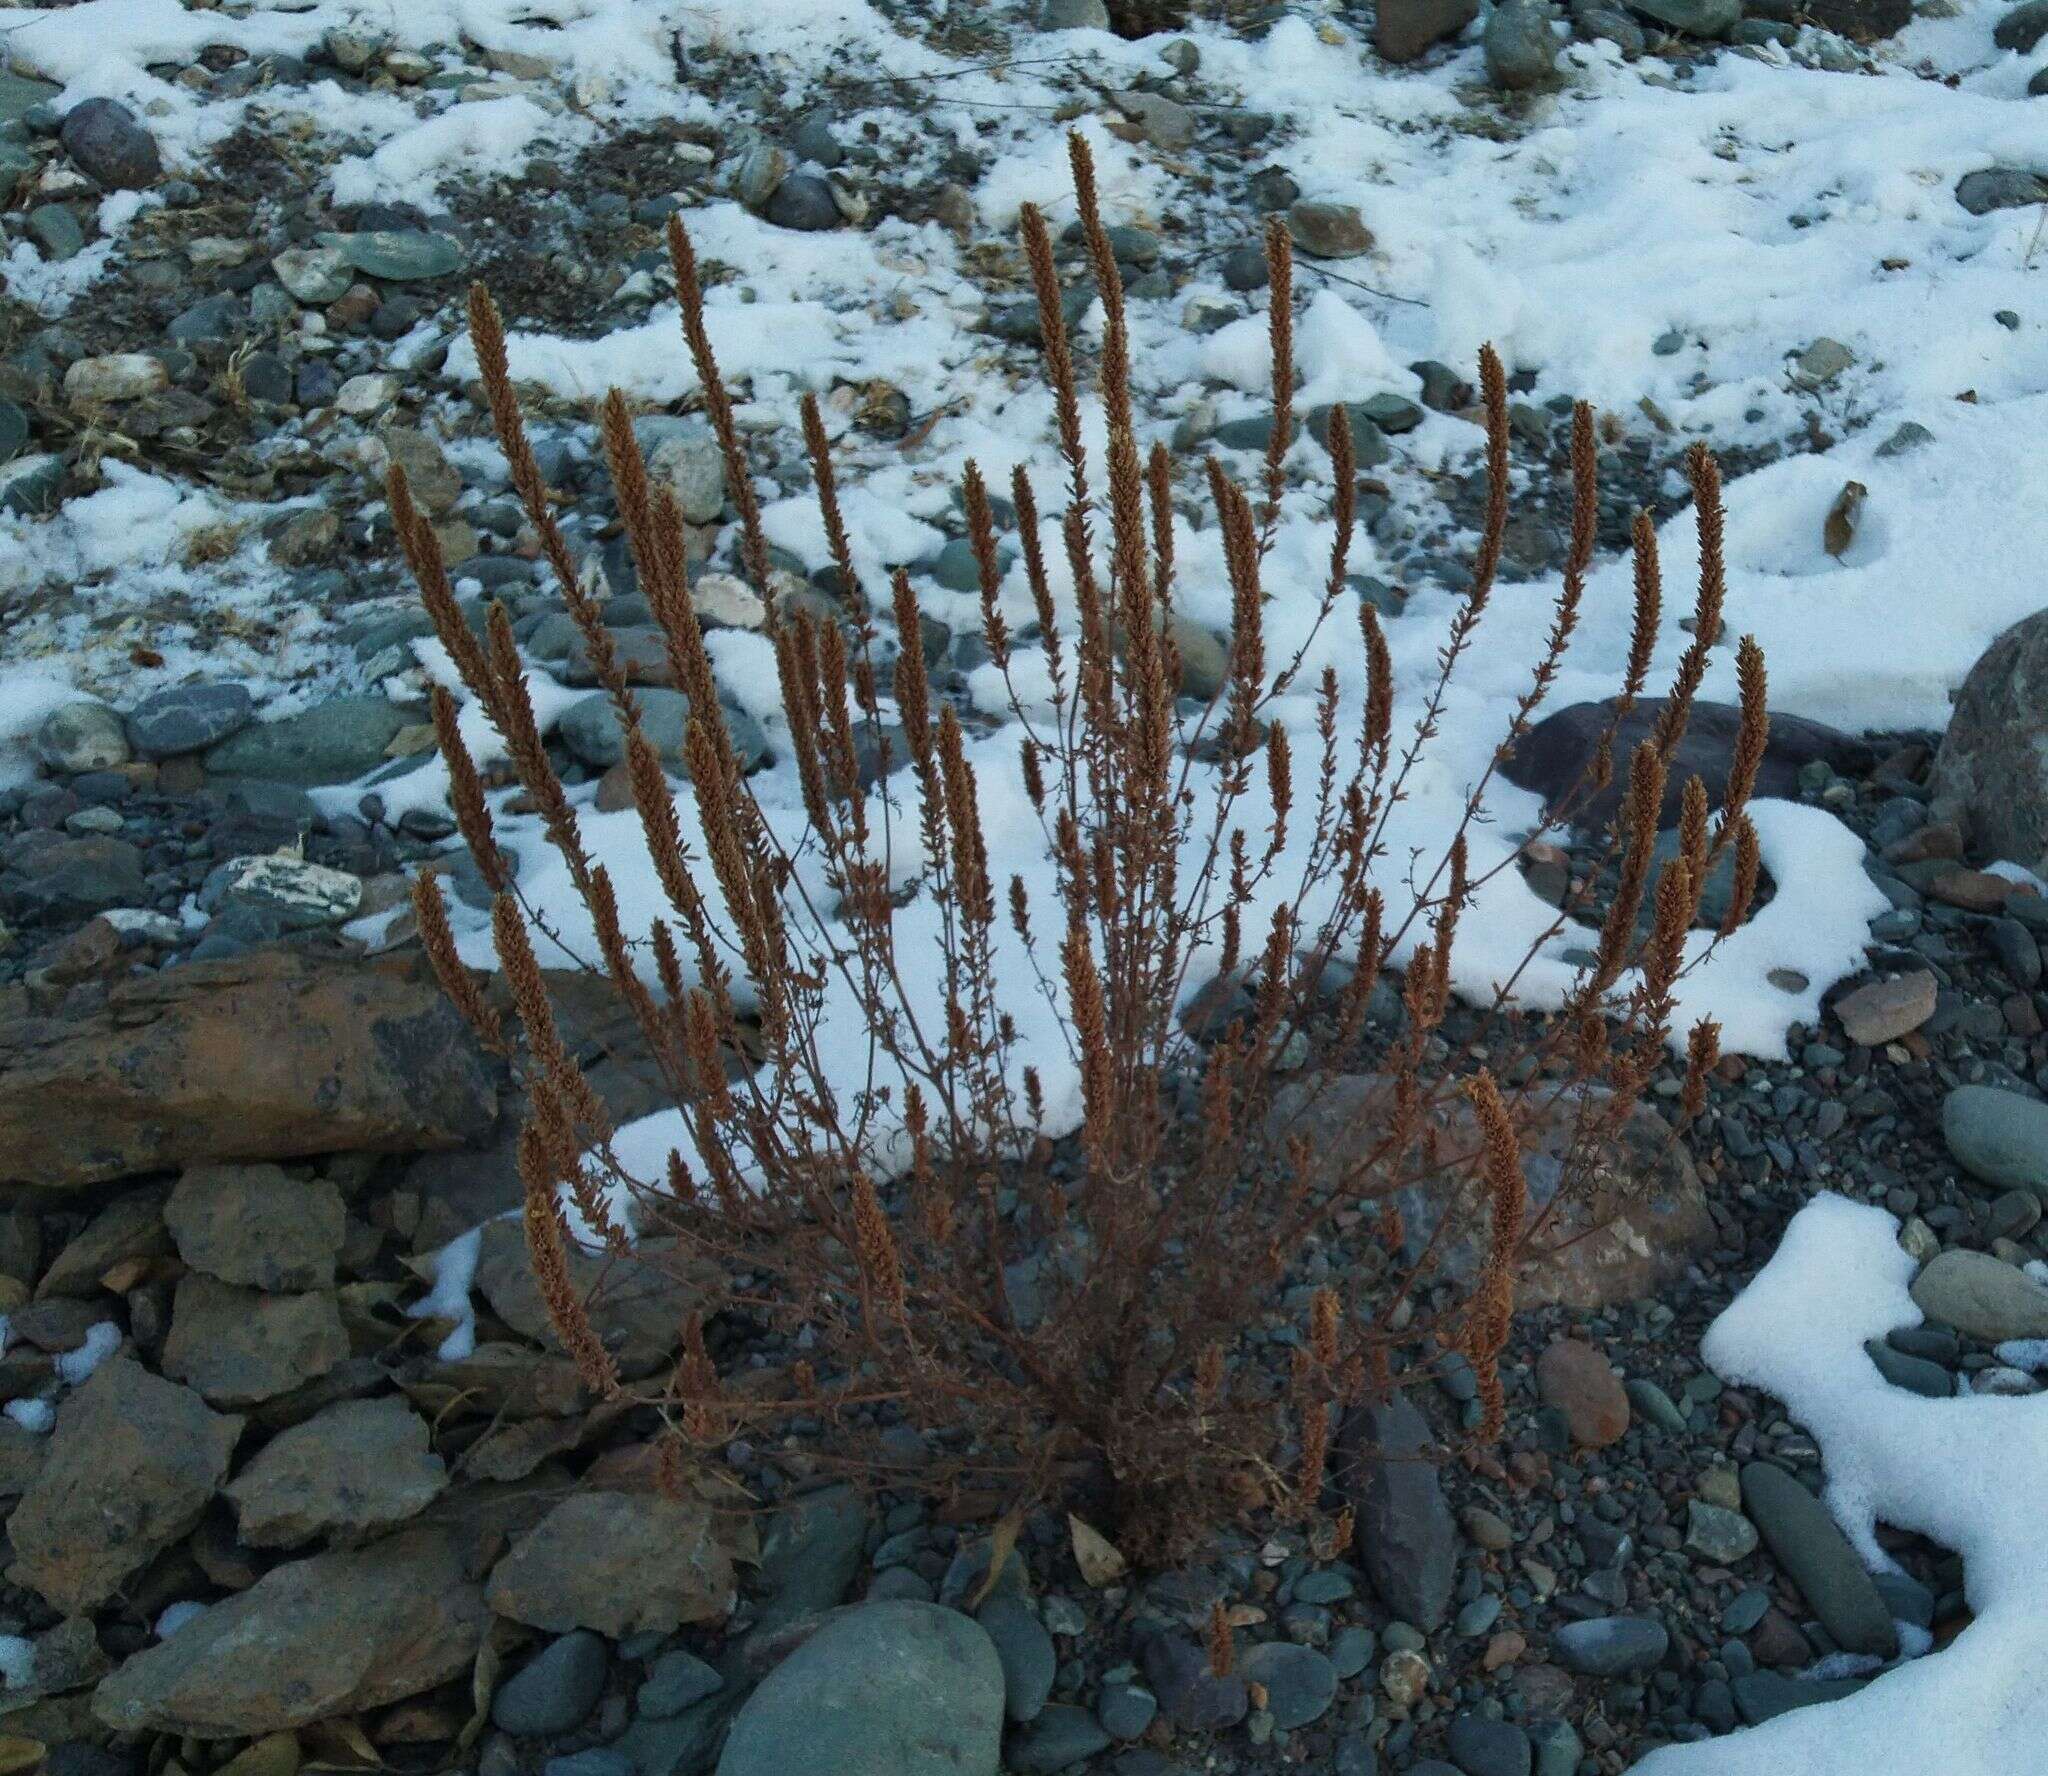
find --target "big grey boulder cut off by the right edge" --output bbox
[1931,610,2048,866]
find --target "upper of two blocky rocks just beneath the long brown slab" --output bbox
[164,1166,346,1291]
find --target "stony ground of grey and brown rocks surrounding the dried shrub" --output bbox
[0,0,2048,1776]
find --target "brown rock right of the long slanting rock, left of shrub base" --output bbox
[489,1493,733,1639]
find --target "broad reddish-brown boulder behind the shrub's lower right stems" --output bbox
[1270,1073,1716,1313]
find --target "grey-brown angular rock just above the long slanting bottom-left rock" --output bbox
[227,1395,444,1548]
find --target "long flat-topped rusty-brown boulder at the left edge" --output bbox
[0,950,498,1190]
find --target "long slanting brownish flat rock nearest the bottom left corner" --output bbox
[92,1530,489,1739]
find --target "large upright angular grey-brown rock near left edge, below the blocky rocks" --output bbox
[8,1356,242,1616]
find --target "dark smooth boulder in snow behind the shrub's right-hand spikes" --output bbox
[1503,696,1872,828]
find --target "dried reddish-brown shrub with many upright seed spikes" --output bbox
[403,141,1765,1556]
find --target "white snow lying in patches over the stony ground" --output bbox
[0,0,2048,1776]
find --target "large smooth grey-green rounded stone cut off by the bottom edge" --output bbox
[719,1602,1004,1776]
